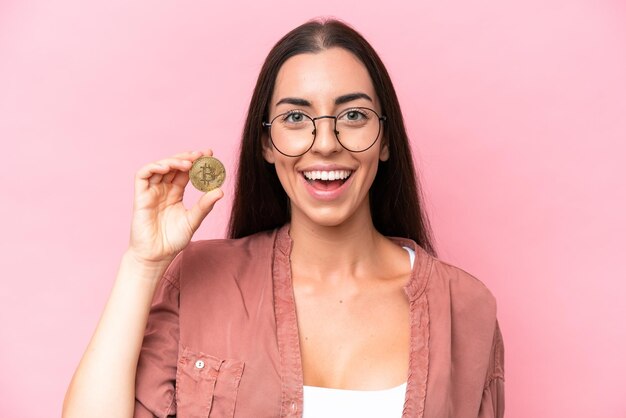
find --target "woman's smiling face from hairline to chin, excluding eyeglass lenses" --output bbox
[264,48,389,226]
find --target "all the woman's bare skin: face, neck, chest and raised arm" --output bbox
[63,49,410,418]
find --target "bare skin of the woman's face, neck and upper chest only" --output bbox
[264,48,410,390]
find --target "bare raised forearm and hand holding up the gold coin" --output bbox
[63,151,219,418]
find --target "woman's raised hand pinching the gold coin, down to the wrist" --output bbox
[129,150,224,263]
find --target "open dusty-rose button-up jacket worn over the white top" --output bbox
[135,225,504,418]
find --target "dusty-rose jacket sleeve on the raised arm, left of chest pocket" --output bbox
[134,257,180,418]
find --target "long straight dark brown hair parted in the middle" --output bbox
[228,19,436,255]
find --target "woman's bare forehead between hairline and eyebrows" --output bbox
[272,48,378,106]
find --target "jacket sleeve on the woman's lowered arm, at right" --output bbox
[478,321,504,418]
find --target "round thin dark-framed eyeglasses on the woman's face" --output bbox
[263,107,387,157]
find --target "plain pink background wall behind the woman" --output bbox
[0,0,626,418]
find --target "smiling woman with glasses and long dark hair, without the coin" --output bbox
[64,20,504,417]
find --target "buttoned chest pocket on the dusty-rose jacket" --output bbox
[176,347,244,418]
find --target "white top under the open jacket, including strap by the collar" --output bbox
[302,247,415,418]
